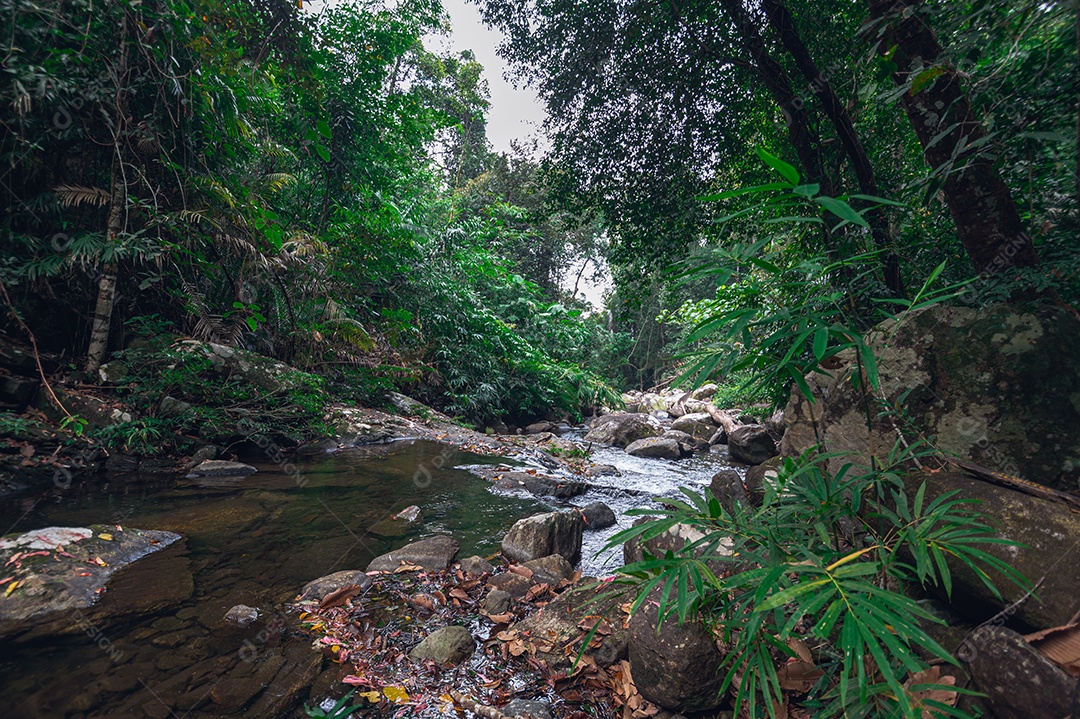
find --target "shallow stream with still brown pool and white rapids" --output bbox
[0,432,728,719]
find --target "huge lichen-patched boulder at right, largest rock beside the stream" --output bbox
[781,306,1080,490]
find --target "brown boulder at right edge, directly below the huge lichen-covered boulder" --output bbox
[906,472,1080,629]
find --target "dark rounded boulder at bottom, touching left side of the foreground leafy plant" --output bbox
[629,592,724,713]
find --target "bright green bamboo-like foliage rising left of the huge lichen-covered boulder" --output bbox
[671,150,958,405]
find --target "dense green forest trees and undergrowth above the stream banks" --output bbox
[0,0,1080,424]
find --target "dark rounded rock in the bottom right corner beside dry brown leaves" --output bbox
[959,625,1080,719]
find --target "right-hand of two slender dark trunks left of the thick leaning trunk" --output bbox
[761,0,904,297]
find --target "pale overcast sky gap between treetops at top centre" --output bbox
[424,0,544,152]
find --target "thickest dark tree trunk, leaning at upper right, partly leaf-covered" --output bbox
[867,0,1038,274]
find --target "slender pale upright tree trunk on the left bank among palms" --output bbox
[85,11,127,381]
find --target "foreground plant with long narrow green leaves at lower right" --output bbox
[609,443,1027,719]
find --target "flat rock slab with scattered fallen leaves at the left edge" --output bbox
[0,526,180,636]
